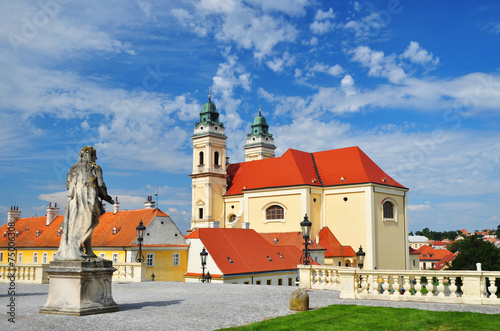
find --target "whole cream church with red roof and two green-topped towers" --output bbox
[190,96,410,269]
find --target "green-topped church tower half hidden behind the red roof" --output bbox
[243,107,276,161]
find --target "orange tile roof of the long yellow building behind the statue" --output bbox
[0,209,168,248]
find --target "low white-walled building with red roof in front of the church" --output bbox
[185,228,318,286]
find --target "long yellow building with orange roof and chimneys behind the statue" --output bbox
[0,197,189,282]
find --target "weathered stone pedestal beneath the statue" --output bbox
[40,259,119,316]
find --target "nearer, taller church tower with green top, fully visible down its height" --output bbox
[190,95,227,229]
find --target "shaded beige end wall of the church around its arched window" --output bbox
[374,192,408,269]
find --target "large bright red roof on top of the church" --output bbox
[226,147,404,195]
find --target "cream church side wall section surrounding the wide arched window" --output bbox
[248,194,304,233]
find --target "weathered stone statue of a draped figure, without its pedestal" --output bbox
[54,146,114,261]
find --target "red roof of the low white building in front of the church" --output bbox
[186,228,317,275]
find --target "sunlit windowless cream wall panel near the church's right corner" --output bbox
[325,191,366,249]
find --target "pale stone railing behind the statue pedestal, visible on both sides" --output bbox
[0,262,146,284]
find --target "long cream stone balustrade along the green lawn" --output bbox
[299,265,500,305]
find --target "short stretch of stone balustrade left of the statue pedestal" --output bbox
[0,263,49,284]
